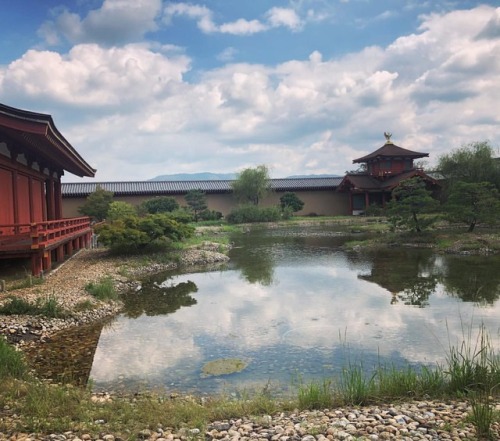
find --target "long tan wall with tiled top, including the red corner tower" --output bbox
[62,134,436,216]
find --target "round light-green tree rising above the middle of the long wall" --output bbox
[231,165,271,205]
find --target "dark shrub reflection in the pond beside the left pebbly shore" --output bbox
[123,276,198,318]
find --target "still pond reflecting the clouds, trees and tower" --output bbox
[29,227,500,394]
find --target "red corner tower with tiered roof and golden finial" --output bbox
[338,133,439,214]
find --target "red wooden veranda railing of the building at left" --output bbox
[0,217,90,251]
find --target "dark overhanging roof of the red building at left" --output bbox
[0,103,95,177]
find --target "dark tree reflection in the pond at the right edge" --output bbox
[443,256,500,305]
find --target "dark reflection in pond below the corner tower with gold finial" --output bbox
[358,250,438,308]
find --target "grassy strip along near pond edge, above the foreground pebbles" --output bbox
[0,326,500,439]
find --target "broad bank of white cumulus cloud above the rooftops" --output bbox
[0,3,500,180]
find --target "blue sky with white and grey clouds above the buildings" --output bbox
[0,0,500,182]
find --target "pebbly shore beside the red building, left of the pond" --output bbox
[0,242,229,349]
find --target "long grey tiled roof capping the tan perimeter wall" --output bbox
[61,177,342,197]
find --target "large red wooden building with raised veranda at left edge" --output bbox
[0,104,95,276]
